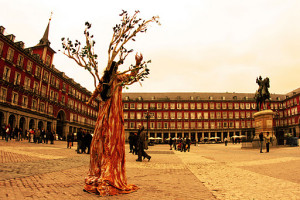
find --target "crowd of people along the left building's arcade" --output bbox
[1,124,55,144]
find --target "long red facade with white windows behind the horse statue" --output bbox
[123,89,300,144]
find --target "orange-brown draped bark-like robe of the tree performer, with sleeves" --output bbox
[84,72,139,196]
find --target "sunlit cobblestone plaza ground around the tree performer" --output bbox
[0,140,300,200]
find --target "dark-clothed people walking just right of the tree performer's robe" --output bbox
[128,124,151,162]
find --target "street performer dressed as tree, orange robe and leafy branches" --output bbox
[62,11,159,196]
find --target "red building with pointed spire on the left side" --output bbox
[0,21,99,137]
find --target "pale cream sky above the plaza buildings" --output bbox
[0,0,300,94]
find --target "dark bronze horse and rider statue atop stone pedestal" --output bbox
[254,76,270,111]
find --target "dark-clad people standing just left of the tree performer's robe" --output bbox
[71,128,93,154]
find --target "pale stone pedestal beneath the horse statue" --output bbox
[252,110,277,148]
